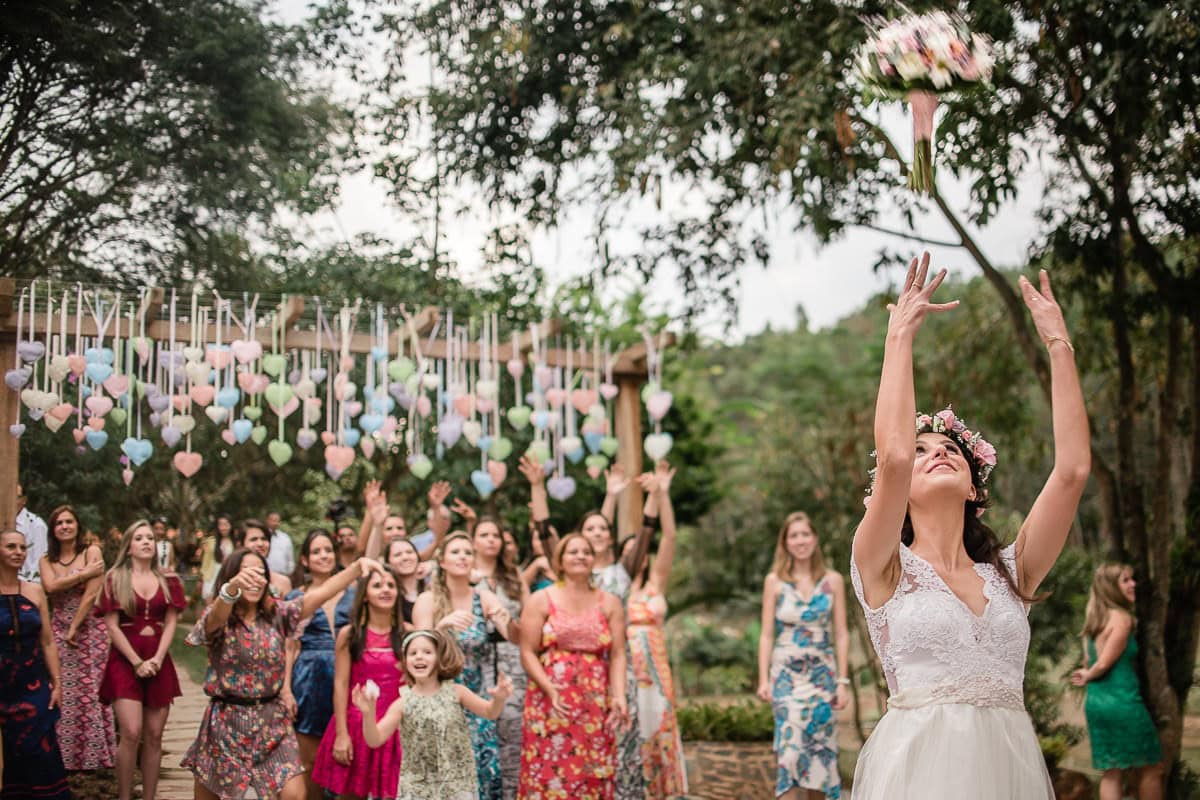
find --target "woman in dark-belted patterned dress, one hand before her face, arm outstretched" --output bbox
[182,549,379,800]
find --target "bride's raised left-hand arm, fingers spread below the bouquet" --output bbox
[853,253,958,607]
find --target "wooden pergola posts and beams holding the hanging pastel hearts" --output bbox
[0,278,674,530]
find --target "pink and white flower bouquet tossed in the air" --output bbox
[858,11,995,194]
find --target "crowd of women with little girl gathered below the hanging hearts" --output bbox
[0,459,686,800]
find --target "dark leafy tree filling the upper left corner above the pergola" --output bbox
[0,0,350,287]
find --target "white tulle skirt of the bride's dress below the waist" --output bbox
[852,703,1054,800]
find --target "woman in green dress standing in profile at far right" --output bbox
[1070,564,1163,800]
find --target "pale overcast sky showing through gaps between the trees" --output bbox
[277,0,1042,336]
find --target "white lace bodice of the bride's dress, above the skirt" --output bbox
[850,545,1030,709]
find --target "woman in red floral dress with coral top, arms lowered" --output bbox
[517,534,629,800]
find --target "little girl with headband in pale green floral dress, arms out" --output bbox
[353,630,512,800]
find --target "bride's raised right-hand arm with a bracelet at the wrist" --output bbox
[1016,270,1092,595]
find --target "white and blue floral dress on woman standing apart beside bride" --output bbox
[770,578,841,798]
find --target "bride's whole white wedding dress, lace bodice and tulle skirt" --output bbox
[851,545,1054,800]
